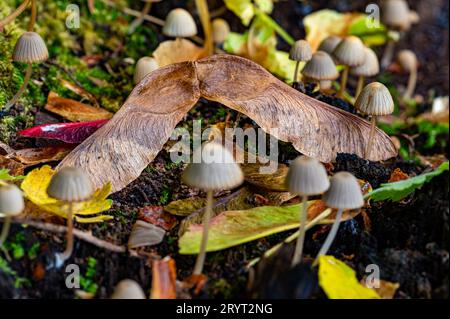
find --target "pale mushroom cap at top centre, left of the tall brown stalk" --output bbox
[162,8,197,38]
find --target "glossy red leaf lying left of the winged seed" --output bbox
[18,120,108,143]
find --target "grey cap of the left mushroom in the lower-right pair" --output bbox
[285,156,330,196]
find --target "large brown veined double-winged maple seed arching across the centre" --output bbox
[59,55,397,191]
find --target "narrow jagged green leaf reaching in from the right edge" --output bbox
[365,162,448,202]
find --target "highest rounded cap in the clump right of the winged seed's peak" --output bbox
[333,35,366,67]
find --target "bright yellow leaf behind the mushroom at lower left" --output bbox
[21,165,112,223]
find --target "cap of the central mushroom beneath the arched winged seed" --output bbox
[183,141,244,191]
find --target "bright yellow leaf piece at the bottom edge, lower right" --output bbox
[319,255,380,299]
